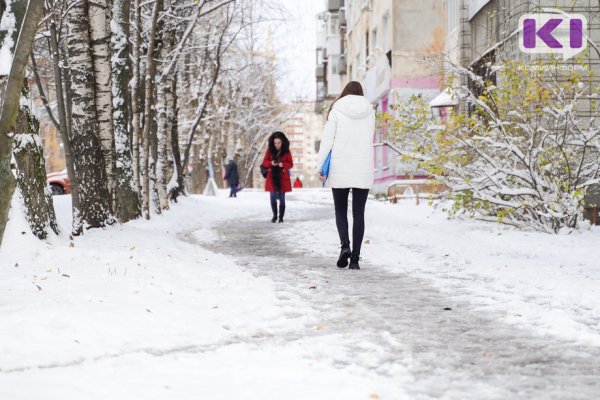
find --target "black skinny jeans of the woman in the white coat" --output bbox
[331,188,369,255]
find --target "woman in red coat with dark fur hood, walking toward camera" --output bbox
[262,132,294,223]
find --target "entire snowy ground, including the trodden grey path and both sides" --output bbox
[0,190,600,400]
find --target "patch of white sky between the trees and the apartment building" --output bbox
[273,0,325,101]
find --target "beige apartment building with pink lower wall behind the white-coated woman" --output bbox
[342,0,446,192]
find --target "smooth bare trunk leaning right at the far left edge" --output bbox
[0,1,44,244]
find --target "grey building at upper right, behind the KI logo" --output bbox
[445,0,600,111]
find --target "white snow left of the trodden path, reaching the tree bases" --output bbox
[0,192,404,400]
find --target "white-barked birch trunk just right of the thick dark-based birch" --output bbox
[88,0,115,201]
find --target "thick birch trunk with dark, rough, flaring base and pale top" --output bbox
[66,0,113,235]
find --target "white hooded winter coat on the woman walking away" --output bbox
[317,95,375,189]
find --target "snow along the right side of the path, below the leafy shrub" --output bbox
[290,193,600,346]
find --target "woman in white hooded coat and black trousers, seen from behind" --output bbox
[317,81,375,269]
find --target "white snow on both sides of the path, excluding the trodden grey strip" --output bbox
[0,190,600,400]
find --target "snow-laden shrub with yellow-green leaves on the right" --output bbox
[380,63,600,232]
